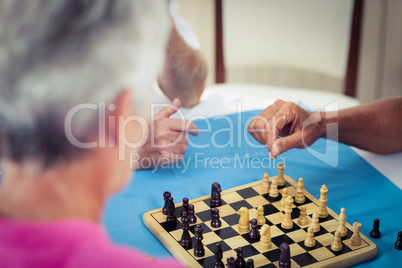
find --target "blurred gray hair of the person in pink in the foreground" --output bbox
[0,0,169,166]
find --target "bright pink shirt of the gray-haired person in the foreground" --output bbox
[0,220,182,268]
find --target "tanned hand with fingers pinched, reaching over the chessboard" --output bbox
[247,100,323,159]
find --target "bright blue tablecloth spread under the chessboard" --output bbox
[103,111,402,267]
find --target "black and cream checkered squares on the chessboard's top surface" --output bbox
[146,176,372,267]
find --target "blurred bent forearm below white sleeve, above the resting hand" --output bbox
[158,28,207,107]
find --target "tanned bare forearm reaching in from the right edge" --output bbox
[322,97,402,154]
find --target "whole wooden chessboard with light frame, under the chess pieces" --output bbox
[143,175,377,267]
